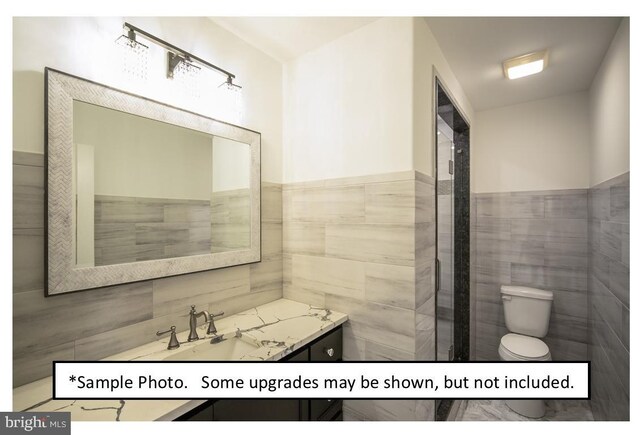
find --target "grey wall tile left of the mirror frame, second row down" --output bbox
[13,165,45,229]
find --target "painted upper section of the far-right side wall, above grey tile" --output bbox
[589,18,629,186]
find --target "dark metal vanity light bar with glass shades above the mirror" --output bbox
[116,22,241,90]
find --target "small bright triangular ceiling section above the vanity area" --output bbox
[210,17,378,62]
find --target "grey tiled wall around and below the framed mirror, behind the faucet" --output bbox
[13,152,283,386]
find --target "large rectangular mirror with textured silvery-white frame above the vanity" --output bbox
[45,68,260,295]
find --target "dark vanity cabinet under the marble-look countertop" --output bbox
[176,326,342,421]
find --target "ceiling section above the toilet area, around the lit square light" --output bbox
[425,17,620,111]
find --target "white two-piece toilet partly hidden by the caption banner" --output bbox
[498,285,553,418]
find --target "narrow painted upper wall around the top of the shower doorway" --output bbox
[413,18,475,179]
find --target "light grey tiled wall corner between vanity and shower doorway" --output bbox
[283,171,435,420]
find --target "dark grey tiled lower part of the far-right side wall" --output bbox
[588,172,630,420]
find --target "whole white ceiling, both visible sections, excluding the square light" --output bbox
[210,17,620,111]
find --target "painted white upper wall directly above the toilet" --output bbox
[471,91,589,193]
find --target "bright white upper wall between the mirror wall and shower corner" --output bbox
[283,18,413,182]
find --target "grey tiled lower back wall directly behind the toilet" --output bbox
[472,189,587,360]
